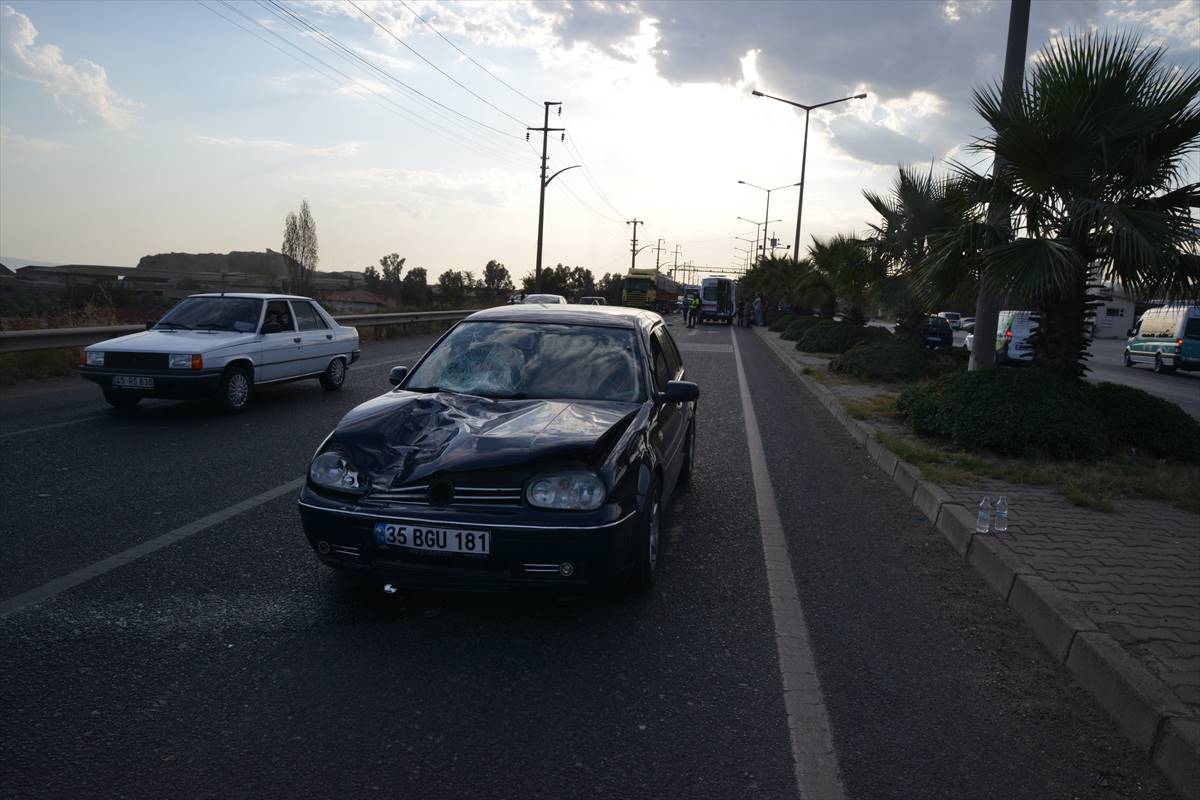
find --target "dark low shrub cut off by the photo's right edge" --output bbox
[1087,384,1200,464]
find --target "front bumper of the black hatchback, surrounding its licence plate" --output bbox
[299,486,638,591]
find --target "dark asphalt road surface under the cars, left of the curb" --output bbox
[0,325,1170,800]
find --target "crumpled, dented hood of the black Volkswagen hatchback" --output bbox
[319,391,641,487]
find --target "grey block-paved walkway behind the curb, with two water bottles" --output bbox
[757,329,1200,753]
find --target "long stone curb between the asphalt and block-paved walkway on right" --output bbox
[755,329,1200,800]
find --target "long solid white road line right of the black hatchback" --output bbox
[730,331,846,800]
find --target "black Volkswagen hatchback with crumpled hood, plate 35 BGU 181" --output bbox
[300,305,700,590]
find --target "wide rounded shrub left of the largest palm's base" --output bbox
[896,368,1110,461]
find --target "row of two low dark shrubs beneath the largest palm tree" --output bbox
[896,368,1200,463]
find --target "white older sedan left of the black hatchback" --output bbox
[79,294,359,411]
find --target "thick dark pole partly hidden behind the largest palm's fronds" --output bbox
[967,0,1030,369]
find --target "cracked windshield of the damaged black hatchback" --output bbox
[404,323,643,402]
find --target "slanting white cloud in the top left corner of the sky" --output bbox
[0,6,144,131]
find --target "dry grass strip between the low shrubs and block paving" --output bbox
[873,429,1200,513]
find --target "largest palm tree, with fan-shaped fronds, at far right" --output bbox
[926,34,1200,377]
